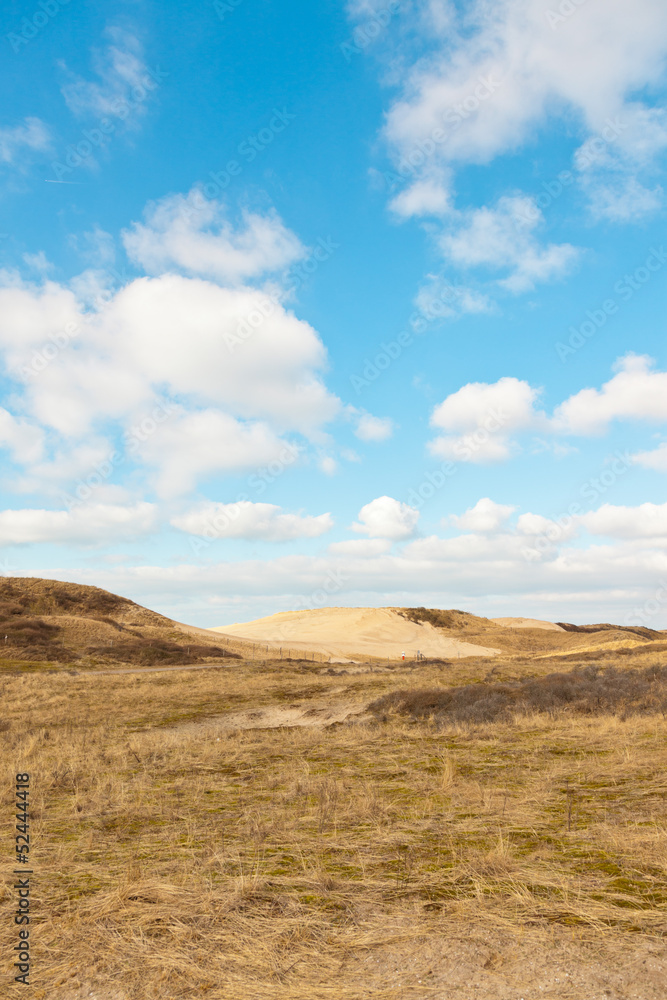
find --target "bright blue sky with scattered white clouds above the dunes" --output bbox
[0,0,667,628]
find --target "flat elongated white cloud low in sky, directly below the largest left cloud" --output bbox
[171,500,333,542]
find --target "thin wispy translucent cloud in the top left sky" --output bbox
[61,28,155,117]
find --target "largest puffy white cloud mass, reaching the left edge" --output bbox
[0,227,342,493]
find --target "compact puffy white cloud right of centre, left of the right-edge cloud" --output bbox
[429,377,546,464]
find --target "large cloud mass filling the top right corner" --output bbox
[385,0,667,207]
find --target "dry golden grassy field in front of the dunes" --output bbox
[0,649,667,1000]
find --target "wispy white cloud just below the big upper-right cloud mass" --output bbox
[439,196,578,292]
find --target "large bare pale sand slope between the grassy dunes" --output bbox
[211,608,500,660]
